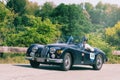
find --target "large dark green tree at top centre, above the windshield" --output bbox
[52,4,91,36]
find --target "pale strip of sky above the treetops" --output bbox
[29,0,120,6]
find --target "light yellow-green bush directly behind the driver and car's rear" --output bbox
[87,33,114,56]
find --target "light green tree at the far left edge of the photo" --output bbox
[0,2,14,45]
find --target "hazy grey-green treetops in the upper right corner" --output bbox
[86,2,120,27]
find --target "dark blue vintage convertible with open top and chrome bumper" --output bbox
[26,37,107,71]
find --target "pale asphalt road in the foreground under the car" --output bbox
[0,64,120,80]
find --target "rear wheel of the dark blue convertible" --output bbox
[93,54,103,70]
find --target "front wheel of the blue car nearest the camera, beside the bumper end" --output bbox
[61,53,72,71]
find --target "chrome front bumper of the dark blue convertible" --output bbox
[25,57,63,63]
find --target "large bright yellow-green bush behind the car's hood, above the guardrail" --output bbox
[6,15,60,46]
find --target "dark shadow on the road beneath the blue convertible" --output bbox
[13,64,93,71]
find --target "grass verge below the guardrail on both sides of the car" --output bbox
[0,53,120,64]
